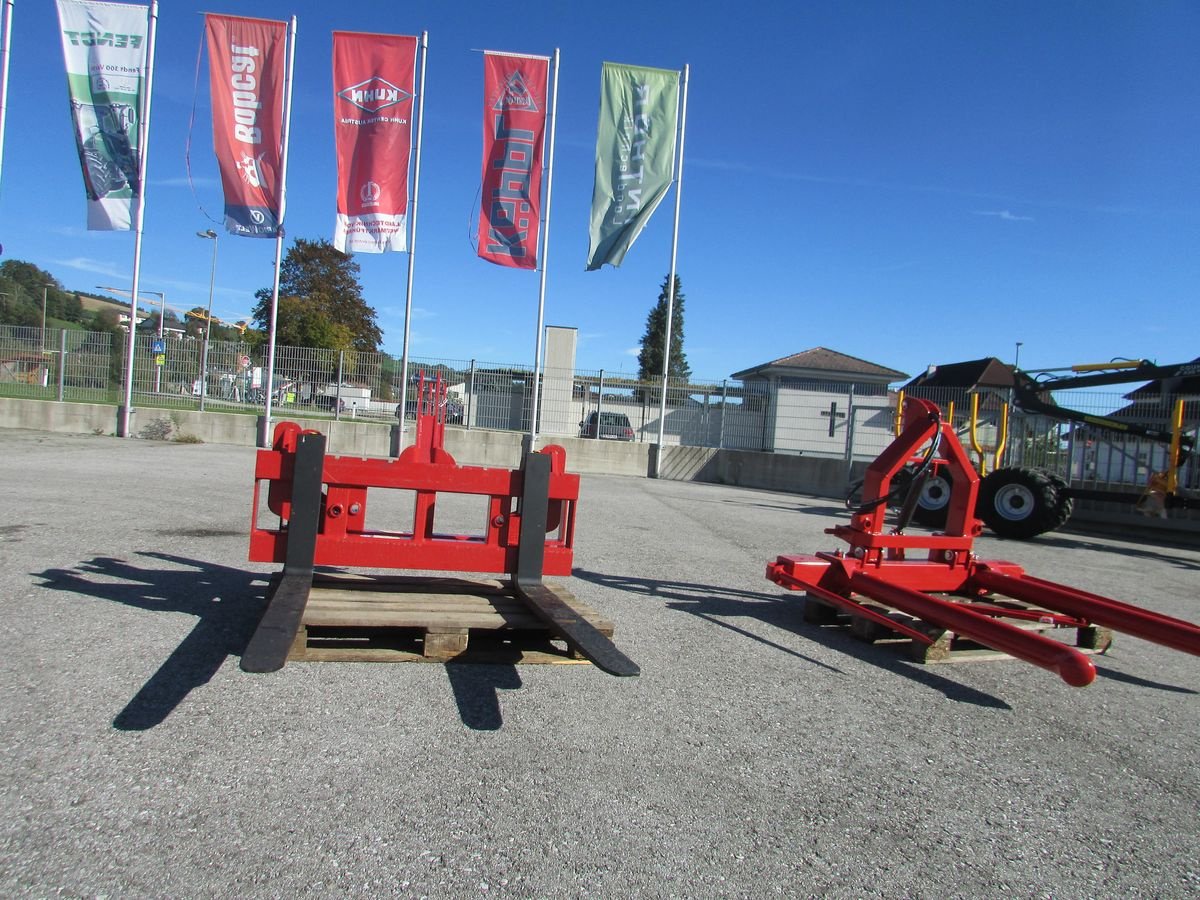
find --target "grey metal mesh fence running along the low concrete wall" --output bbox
[0,326,1200,501]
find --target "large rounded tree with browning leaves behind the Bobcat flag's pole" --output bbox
[253,238,383,350]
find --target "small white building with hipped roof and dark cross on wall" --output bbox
[731,347,908,458]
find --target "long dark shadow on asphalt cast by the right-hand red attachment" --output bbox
[572,569,1012,709]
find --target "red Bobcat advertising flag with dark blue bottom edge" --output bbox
[204,13,287,238]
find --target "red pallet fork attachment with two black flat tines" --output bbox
[241,377,640,676]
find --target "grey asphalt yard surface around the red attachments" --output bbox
[0,431,1200,898]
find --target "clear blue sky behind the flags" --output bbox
[0,0,1200,380]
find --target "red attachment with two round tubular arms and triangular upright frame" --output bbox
[767,397,1200,686]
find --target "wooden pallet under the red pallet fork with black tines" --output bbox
[276,572,613,664]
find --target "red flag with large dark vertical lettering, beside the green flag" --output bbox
[479,53,550,269]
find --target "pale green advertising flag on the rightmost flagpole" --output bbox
[587,62,679,271]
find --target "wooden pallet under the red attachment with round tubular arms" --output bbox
[804,594,1112,664]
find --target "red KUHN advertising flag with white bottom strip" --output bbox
[334,31,418,253]
